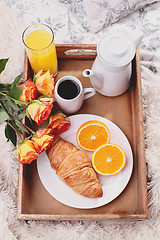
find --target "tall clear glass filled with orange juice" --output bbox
[22,23,58,76]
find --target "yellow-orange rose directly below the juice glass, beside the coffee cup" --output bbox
[34,69,54,97]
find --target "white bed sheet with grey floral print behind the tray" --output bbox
[5,0,160,78]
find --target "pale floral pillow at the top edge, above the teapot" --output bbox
[71,0,156,33]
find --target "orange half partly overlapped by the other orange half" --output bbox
[76,120,111,152]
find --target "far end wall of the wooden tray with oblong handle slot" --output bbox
[56,44,97,59]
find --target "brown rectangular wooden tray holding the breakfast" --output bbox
[17,45,148,220]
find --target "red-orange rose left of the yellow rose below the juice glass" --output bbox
[18,78,37,102]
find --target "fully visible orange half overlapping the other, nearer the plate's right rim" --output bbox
[92,143,126,176]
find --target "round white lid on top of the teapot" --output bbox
[97,33,135,66]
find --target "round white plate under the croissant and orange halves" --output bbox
[37,114,133,209]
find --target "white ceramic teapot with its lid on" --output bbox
[83,31,143,96]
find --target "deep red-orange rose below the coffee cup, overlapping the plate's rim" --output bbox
[48,113,70,134]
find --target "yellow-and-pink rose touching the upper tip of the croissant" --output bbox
[32,128,54,153]
